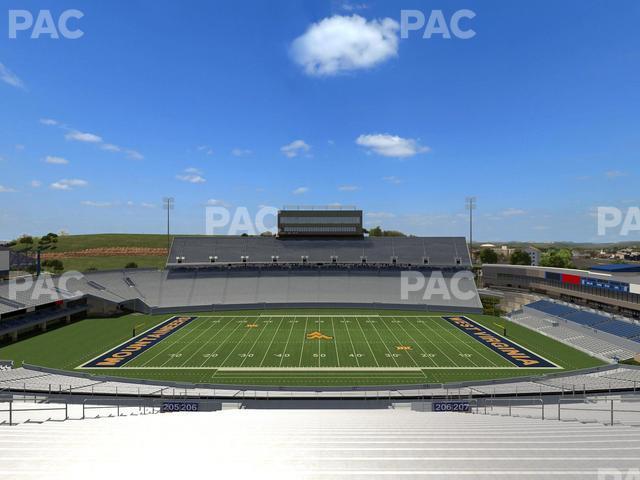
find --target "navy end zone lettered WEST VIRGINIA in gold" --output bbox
[442,317,558,368]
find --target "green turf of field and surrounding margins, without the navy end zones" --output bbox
[0,310,602,386]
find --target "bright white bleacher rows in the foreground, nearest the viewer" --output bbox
[2,409,640,480]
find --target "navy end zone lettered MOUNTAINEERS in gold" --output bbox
[81,317,196,368]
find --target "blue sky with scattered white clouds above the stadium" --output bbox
[0,0,640,241]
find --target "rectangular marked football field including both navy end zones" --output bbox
[78,314,557,372]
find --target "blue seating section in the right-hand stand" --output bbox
[527,300,640,343]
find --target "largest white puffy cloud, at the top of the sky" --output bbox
[291,15,399,76]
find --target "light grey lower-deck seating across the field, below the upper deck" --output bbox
[69,268,481,311]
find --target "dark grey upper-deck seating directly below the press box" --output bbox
[167,236,471,268]
